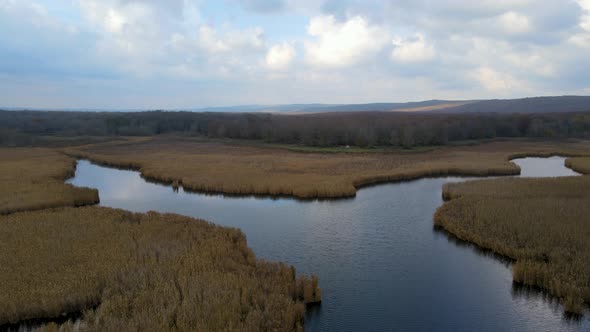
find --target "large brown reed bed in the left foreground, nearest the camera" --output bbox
[0,207,321,331]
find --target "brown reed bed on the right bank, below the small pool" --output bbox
[435,176,590,314]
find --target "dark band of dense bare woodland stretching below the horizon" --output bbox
[0,111,590,147]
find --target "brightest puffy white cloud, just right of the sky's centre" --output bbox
[305,15,389,67]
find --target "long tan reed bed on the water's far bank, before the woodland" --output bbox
[66,138,590,198]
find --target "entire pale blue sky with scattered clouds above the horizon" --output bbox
[0,0,590,109]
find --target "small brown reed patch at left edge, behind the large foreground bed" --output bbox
[0,148,98,214]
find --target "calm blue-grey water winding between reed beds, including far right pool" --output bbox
[70,157,590,331]
